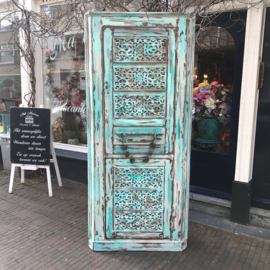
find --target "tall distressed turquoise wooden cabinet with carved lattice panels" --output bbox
[85,12,195,251]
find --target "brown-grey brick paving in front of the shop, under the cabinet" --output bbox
[0,173,270,270]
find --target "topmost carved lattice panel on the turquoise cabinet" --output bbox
[114,37,166,62]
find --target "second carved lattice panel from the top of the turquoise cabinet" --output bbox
[114,67,166,90]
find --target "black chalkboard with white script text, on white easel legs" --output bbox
[10,108,51,165]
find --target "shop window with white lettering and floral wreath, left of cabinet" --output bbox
[44,35,87,146]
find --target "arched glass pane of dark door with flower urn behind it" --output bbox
[192,26,235,153]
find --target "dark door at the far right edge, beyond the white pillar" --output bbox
[252,8,270,209]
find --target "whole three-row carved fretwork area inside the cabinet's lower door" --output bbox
[114,167,164,231]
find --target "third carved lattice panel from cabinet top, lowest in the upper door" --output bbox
[114,94,166,118]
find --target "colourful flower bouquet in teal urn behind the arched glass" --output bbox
[192,81,231,142]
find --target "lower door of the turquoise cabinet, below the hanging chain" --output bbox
[106,159,173,239]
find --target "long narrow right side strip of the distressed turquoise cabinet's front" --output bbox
[172,17,189,241]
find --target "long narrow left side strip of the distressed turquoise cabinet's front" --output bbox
[91,17,105,241]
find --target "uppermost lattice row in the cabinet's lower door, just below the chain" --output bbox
[114,167,164,188]
